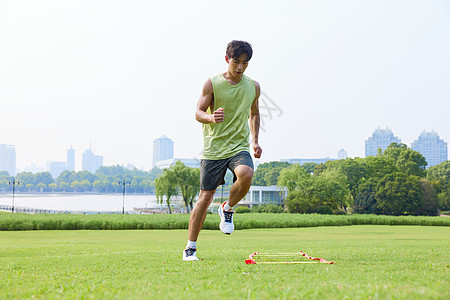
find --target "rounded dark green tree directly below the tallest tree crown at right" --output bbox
[375,172,424,216]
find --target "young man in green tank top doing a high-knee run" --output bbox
[183,41,262,261]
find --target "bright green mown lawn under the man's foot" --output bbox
[0,225,450,299]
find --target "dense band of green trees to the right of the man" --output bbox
[253,143,450,215]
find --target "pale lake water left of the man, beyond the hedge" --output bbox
[0,193,172,212]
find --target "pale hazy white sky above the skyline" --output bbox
[0,0,450,170]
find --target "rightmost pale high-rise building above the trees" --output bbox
[411,131,448,168]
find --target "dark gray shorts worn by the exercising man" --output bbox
[200,151,253,191]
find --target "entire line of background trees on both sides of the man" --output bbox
[0,143,450,215]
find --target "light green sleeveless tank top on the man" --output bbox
[202,73,256,160]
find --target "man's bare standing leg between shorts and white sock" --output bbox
[188,190,216,242]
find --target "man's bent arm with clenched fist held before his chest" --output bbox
[195,79,225,124]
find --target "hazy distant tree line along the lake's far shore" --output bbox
[0,165,162,193]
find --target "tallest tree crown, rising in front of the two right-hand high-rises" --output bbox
[383,143,427,177]
